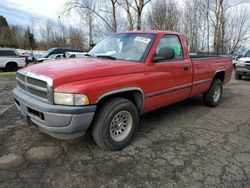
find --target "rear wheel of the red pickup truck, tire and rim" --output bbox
[203,79,223,107]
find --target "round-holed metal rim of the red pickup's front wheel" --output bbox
[110,110,133,142]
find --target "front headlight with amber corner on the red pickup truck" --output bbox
[54,93,89,106]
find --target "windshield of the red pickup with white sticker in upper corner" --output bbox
[89,33,156,62]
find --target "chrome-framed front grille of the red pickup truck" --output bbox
[16,71,53,103]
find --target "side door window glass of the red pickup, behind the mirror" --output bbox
[156,35,183,60]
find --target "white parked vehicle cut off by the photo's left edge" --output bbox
[0,48,27,72]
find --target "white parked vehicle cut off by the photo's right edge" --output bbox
[235,49,250,80]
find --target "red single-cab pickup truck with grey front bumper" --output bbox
[13,31,232,150]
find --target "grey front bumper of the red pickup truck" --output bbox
[13,88,96,139]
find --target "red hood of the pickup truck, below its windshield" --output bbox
[25,58,144,87]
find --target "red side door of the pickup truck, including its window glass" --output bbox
[145,34,192,111]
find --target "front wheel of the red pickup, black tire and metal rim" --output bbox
[92,98,139,151]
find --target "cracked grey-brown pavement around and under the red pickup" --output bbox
[0,73,250,188]
